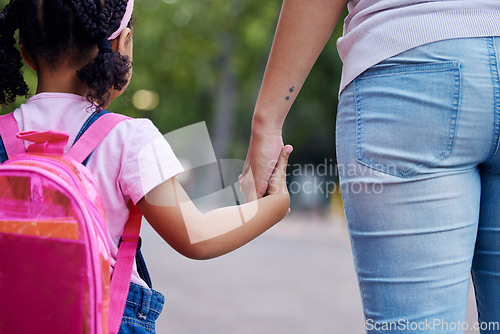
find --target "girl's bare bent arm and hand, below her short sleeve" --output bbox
[138,146,292,259]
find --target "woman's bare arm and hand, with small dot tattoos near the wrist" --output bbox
[240,0,347,200]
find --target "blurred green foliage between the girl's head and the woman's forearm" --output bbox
[122,0,281,141]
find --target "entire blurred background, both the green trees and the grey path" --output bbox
[0,0,482,334]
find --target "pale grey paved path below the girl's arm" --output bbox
[143,214,477,334]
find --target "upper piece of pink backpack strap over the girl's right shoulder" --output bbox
[66,113,129,163]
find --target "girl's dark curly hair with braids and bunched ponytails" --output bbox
[0,0,132,107]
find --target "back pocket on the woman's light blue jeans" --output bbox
[354,61,460,178]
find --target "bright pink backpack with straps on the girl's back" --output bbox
[0,113,141,334]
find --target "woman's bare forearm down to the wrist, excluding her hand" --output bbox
[252,0,347,133]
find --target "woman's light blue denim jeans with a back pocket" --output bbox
[337,37,500,334]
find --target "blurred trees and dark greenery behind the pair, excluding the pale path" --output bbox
[0,0,341,217]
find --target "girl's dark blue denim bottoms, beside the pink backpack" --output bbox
[118,283,165,334]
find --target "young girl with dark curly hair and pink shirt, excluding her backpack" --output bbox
[0,0,291,333]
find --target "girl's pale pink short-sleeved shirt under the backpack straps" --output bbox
[14,93,183,286]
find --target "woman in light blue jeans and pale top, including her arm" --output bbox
[241,0,500,333]
